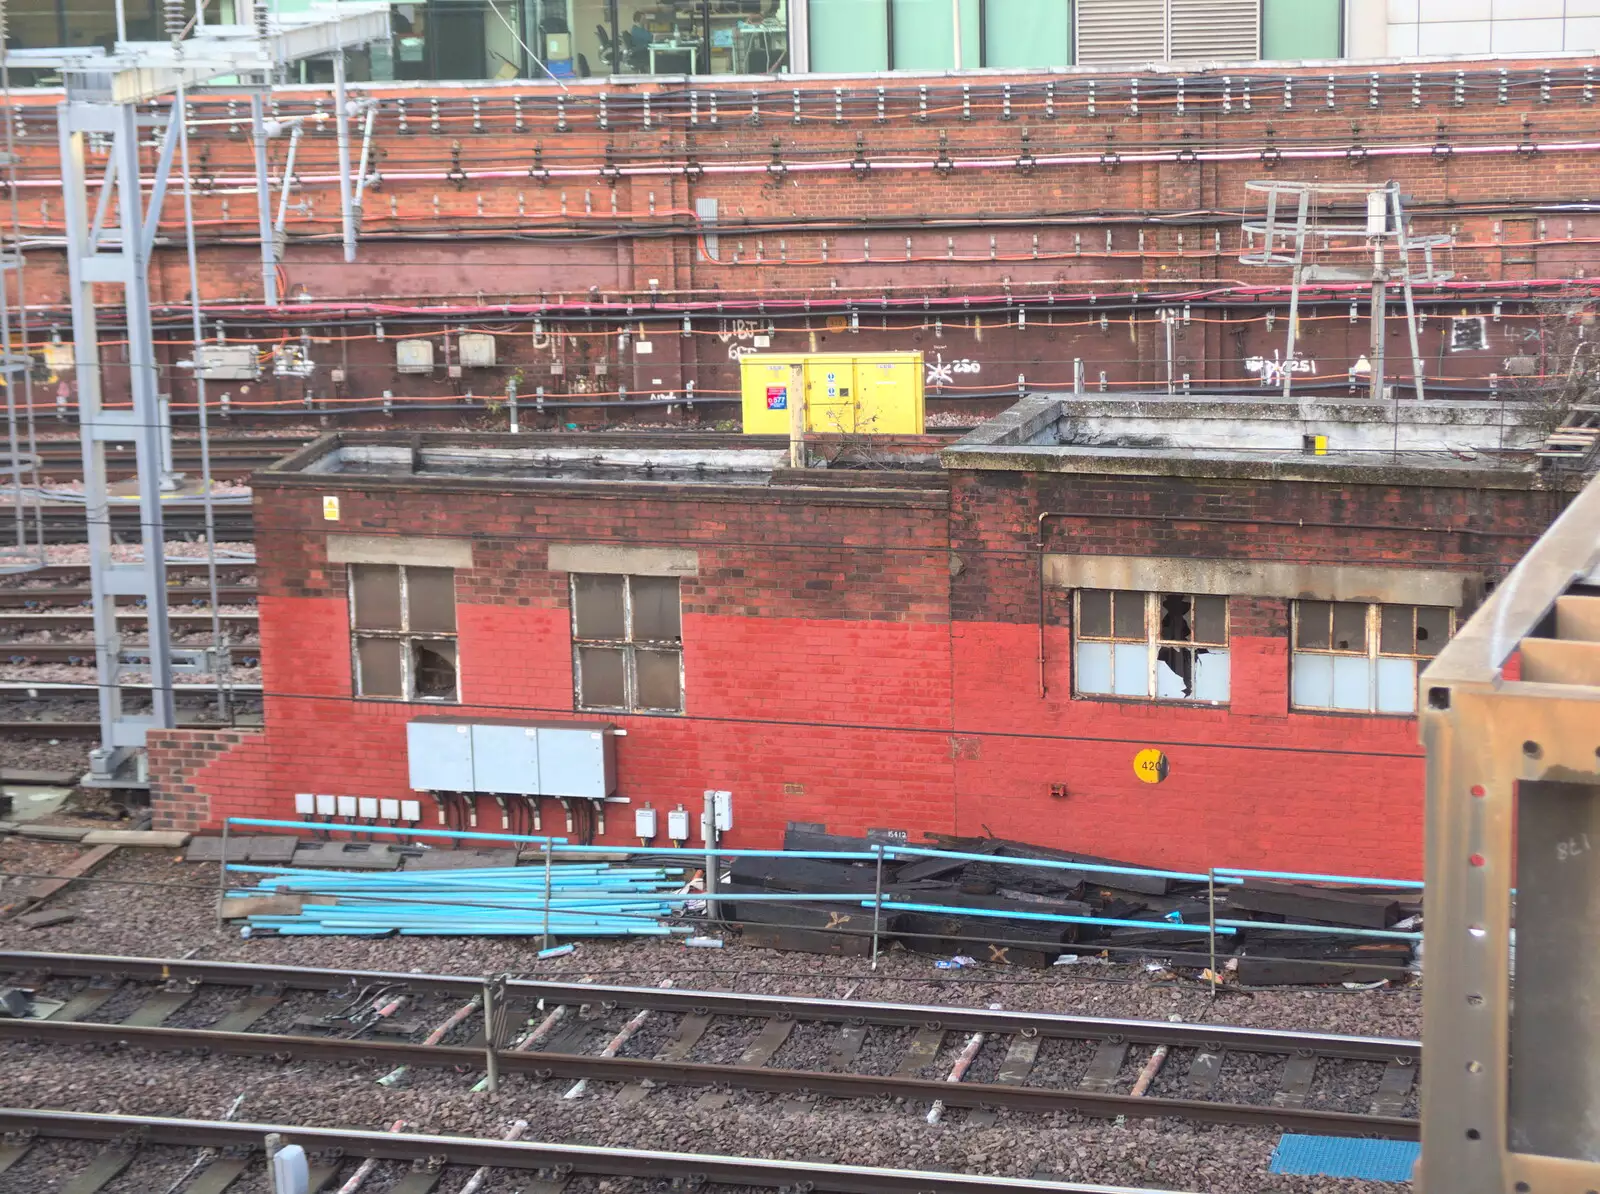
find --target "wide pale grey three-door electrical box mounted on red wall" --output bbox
[406,717,616,800]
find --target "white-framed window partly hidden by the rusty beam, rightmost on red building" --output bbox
[1290,602,1456,717]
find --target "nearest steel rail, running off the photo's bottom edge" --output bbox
[0,1108,1190,1194]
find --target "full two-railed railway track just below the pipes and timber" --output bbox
[0,952,1421,1140]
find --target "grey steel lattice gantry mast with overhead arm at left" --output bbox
[0,0,389,784]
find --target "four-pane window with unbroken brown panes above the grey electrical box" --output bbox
[571,573,683,714]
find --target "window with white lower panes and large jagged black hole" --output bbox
[1072,589,1229,704]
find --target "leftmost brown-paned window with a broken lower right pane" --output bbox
[349,563,461,704]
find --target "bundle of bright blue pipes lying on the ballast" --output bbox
[227,863,690,938]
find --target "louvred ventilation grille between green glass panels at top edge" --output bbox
[1075,0,1261,66]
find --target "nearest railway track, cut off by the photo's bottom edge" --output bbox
[0,1108,1162,1194]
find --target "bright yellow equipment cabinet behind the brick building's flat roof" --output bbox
[739,352,923,435]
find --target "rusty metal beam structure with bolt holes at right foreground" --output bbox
[1418,464,1600,1194]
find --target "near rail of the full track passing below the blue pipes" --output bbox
[0,1011,1419,1140]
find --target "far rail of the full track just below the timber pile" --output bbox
[0,951,1422,1063]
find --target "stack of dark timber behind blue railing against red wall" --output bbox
[720,824,1419,986]
